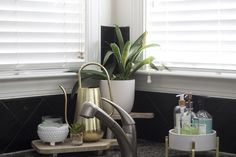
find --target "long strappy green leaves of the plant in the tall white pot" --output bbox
[82,25,159,80]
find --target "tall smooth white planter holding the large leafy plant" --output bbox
[100,79,135,114]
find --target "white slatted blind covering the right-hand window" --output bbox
[145,0,236,73]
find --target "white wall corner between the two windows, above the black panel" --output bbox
[101,0,143,40]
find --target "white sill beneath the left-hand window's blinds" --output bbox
[0,73,77,100]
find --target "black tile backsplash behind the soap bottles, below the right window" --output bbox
[133,91,236,154]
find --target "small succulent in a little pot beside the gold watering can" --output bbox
[70,122,85,145]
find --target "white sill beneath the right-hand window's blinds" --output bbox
[135,71,236,99]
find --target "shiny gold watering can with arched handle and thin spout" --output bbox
[60,62,114,142]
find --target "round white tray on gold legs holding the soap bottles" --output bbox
[169,129,216,151]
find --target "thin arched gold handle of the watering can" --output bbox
[78,62,114,116]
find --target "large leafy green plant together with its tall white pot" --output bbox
[72,25,164,113]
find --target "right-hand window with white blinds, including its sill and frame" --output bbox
[131,0,236,99]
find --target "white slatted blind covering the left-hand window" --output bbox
[0,0,86,75]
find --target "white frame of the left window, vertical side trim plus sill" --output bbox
[0,0,101,99]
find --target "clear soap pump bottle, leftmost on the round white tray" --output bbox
[174,94,186,134]
